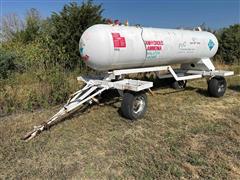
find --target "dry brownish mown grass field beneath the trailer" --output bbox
[0,76,240,179]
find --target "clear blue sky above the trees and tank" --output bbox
[0,0,240,29]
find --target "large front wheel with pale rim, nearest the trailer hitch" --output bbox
[121,92,147,120]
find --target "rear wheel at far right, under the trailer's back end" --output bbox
[208,77,227,97]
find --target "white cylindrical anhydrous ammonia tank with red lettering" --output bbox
[79,24,218,71]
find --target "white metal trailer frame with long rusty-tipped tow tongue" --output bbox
[22,66,234,141]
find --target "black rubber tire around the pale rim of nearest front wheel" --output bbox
[121,92,147,120]
